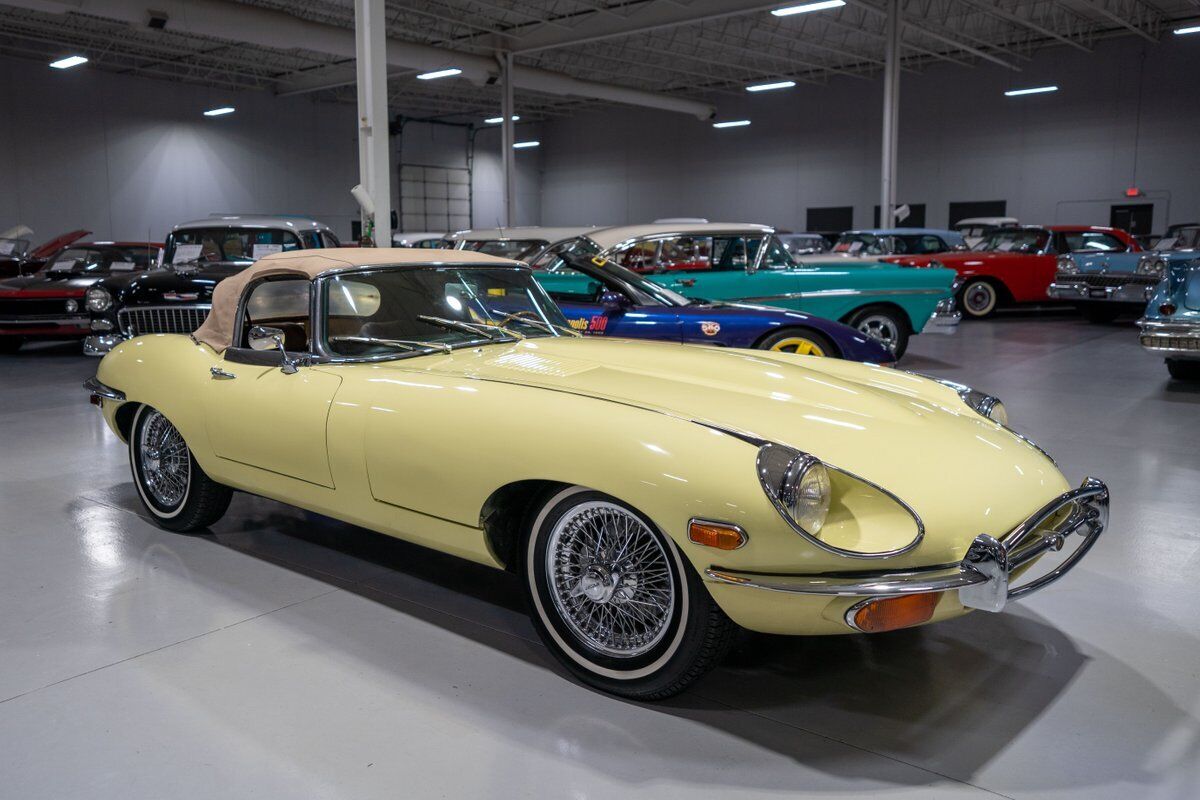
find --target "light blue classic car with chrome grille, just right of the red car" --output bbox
[1046,227,1200,323]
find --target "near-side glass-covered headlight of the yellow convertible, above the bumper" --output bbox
[757,444,925,558]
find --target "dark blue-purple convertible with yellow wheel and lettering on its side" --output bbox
[534,254,895,363]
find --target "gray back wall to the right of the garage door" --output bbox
[541,35,1200,230]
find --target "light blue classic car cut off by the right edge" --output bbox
[1138,225,1200,380]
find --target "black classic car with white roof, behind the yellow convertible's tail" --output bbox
[83,215,341,356]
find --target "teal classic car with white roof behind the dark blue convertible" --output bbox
[559,223,960,359]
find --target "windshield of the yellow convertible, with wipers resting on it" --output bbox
[324,266,570,357]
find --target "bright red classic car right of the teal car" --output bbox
[883,225,1141,319]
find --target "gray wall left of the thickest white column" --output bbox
[0,59,358,241]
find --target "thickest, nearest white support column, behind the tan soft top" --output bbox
[354,0,391,247]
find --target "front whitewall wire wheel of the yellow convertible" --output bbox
[523,487,737,700]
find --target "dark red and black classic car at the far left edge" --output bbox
[0,236,161,354]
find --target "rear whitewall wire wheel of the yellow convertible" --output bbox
[130,405,233,531]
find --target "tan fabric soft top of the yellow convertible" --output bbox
[192,247,523,353]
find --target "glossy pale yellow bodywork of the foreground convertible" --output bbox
[97,335,1069,633]
